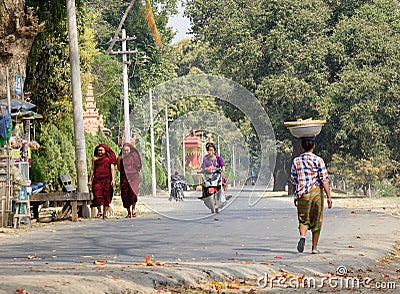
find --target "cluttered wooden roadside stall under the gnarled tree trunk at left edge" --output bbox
[0,99,41,227]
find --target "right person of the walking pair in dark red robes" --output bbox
[117,143,142,218]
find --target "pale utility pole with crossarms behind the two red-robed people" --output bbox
[110,29,138,143]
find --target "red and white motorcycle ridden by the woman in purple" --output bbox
[198,168,226,213]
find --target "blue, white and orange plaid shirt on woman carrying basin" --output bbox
[290,152,328,199]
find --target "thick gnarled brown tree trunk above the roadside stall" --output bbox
[0,0,41,99]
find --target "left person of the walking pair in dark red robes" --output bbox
[88,144,117,219]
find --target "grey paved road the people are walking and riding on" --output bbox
[0,188,400,273]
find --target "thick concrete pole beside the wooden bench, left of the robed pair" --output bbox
[67,0,89,212]
